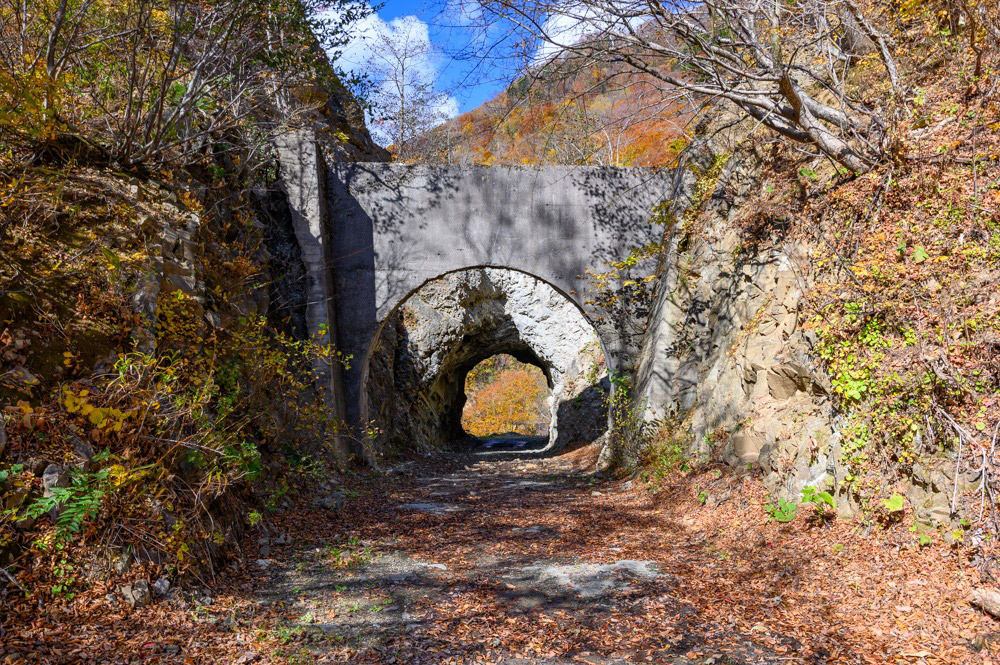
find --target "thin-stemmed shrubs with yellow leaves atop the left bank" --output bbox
[0,0,368,170]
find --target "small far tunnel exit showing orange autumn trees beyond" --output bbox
[461,353,553,449]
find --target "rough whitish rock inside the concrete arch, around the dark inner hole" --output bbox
[362,268,606,450]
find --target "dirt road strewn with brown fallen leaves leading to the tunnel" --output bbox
[0,450,998,665]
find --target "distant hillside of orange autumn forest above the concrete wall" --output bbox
[411,60,693,166]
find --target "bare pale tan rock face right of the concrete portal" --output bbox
[637,147,847,506]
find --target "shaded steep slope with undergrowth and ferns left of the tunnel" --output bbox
[0,67,385,601]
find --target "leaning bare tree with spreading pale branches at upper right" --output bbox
[462,0,901,173]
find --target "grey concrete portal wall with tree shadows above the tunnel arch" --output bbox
[277,131,693,452]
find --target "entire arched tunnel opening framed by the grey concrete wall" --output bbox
[361,267,610,460]
